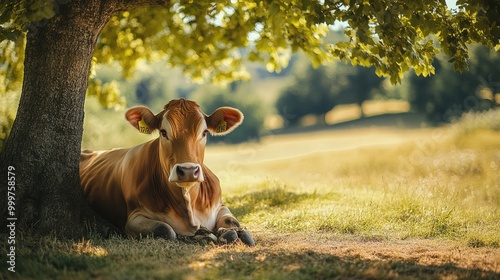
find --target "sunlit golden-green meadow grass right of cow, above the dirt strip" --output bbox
[225,112,500,248]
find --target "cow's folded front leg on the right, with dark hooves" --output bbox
[216,206,255,246]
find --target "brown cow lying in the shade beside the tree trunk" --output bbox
[80,99,255,246]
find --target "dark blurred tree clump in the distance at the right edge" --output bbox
[408,45,500,122]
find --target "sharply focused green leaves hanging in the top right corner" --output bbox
[332,0,500,83]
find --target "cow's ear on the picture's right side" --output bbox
[207,107,243,135]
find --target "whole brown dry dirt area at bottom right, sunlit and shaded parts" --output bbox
[179,231,500,279]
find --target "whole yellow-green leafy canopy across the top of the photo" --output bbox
[0,0,500,89]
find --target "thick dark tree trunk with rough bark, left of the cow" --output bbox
[0,0,113,237]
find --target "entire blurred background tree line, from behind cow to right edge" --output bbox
[0,40,500,148]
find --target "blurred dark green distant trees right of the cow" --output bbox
[275,41,500,126]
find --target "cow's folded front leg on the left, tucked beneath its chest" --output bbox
[125,215,177,240]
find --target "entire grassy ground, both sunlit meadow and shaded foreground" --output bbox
[0,109,500,279]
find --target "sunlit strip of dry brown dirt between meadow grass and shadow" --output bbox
[252,233,500,273]
